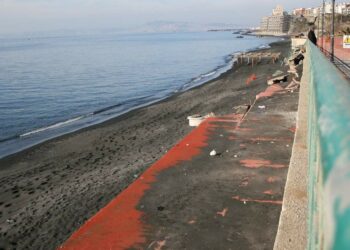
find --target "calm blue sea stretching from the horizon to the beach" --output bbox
[0,32,276,157]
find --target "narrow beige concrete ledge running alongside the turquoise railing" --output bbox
[274,56,310,250]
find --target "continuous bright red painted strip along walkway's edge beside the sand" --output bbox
[60,116,221,250]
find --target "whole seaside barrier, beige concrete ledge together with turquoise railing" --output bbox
[274,42,350,250]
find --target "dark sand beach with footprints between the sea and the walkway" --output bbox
[0,41,290,249]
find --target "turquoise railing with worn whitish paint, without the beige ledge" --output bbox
[307,42,350,250]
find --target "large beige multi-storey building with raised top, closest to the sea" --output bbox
[260,5,290,35]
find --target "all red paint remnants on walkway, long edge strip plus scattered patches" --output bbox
[60,108,290,249]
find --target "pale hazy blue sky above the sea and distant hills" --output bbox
[0,0,321,34]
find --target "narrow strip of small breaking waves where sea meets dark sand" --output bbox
[0,37,284,162]
